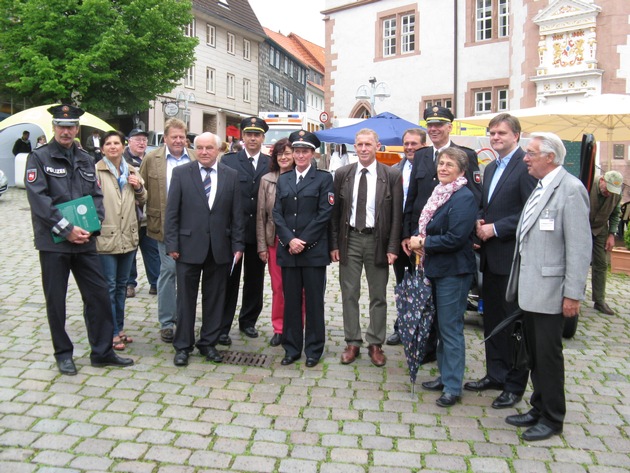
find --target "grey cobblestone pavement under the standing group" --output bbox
[0,188,630,473]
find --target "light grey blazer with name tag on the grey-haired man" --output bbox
[506,168,592,314]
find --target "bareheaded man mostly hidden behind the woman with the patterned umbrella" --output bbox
[385,128,427,345]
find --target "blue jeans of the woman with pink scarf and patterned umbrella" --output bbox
[431,274,473,396]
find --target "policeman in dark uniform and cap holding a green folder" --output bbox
[24,105,133,375]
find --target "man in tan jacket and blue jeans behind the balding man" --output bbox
[140,118,195,343]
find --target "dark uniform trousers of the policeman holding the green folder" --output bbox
[39,251,114,360]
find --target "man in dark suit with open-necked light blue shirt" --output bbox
[464,113,536,409]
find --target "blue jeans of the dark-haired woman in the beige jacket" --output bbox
[98,251,135,336]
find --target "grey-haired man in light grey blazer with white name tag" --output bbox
[505,133,592,441]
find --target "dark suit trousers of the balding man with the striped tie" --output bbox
[173,251,231,352]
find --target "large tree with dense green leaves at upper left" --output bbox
[0,0,198,112]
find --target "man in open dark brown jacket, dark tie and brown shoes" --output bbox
[330,128,403,366]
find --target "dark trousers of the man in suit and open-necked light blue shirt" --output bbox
[482,271,529,396]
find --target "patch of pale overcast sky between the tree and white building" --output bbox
[249,0,326,47]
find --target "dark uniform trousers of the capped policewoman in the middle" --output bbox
[282,266,326,360]
